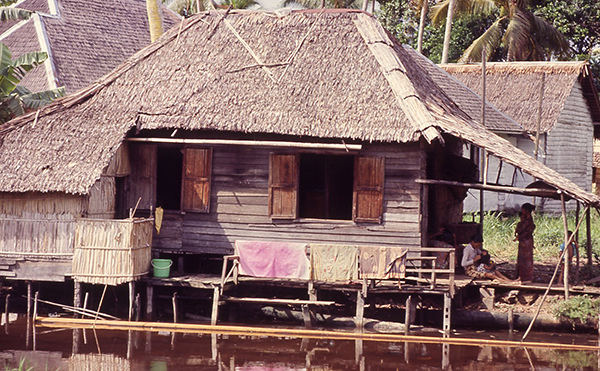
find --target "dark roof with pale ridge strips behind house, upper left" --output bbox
[0,0,181,93]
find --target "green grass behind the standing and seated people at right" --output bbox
[463,212,600,263]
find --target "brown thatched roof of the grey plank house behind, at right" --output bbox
[440,61,600,133]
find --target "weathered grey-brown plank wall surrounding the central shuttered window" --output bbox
[153,143,424,254]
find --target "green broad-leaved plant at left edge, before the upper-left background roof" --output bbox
[0,43,65,123]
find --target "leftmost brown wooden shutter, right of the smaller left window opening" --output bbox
[181,147,212,213]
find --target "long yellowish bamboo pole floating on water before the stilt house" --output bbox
[38,317,600,351]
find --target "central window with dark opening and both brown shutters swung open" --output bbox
[269,153,384,223]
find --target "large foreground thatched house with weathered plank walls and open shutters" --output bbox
[0,10,600,279]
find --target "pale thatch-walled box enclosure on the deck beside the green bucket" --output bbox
[72,218,154,285]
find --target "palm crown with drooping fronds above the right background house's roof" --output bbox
[432,0,570,63]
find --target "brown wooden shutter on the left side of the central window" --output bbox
[269,153,298,219]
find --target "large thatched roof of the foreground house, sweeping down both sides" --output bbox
[0,10,600,208]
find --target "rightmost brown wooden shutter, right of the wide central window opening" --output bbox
[352,156,385,223]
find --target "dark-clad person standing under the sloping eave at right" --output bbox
[514,203,535,283]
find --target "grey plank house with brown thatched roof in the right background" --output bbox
[441,62,600,213]
